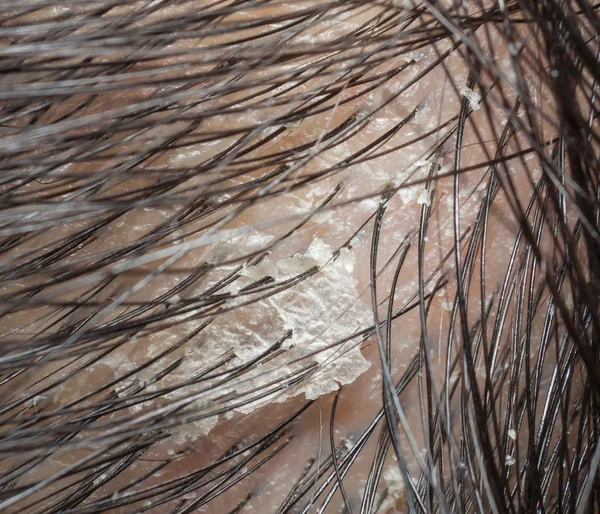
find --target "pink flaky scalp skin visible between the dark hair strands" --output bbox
[0,1,564,513]
